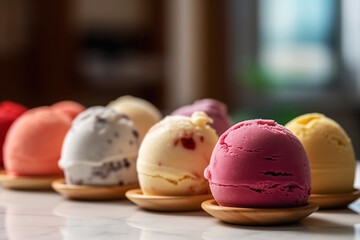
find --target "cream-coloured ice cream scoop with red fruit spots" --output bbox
[137,112,218,196]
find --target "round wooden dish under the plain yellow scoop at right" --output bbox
[309,189,360,209]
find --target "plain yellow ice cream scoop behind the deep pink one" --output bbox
[285,113,356,194]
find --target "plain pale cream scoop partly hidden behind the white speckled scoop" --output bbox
[108,96,162,141]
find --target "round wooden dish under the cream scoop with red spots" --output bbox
[126,189,212,212]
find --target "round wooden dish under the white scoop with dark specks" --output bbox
[52,178,139,201]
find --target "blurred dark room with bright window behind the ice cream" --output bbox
[0,0,360,156]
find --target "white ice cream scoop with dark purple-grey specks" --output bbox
[59,106,139,186]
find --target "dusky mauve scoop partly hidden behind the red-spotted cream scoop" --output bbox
[171,98,232,136]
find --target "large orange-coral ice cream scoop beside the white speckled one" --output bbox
[4,107,71,176]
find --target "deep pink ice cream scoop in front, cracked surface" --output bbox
[204,119,311,208]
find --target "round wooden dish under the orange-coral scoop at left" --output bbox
[0,172,61,190]
